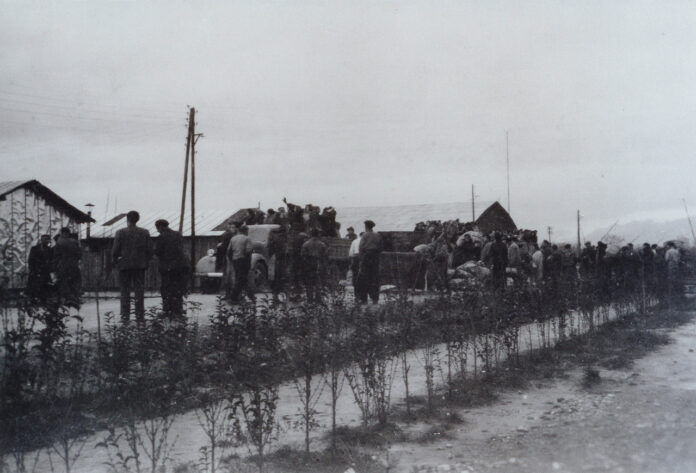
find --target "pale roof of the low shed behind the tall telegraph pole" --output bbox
[90,210,230,238]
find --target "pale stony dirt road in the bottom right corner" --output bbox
[390,312,696,473]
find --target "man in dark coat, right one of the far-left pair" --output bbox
[53,227,82,309]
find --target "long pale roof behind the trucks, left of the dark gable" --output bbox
[336,202,489,235]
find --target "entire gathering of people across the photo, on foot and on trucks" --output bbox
[27,205,685,321]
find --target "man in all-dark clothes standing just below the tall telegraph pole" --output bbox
[155,219,190,320]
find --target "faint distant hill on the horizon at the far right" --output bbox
[585,218,696,244]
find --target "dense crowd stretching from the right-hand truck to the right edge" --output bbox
[416,225,686,306]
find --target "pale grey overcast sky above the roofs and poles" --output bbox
[0,0,696,240]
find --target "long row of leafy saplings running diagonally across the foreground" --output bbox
[0,268,672,472]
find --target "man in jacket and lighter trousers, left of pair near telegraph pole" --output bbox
[111,210,152,322]
